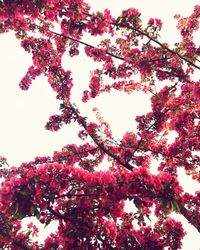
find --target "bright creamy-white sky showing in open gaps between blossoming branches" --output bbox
[0,0,200,250]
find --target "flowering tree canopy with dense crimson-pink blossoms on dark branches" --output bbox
[0,0,200,250]
